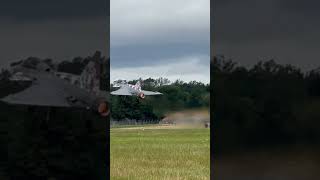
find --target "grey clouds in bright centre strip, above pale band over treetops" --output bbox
[110,0,210,74]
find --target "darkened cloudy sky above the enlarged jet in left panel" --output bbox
[0,0,110,69]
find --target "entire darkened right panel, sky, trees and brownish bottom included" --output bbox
[211,0,320,179]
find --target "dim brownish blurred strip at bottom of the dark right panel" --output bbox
[212,147,320,180]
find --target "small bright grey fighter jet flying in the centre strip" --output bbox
[110,81,162,99]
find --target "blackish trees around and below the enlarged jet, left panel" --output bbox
[0,52,109,179]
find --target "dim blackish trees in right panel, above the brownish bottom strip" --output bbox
[211,56,320,152]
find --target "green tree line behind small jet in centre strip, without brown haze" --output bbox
[110,77,210,122]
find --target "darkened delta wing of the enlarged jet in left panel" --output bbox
[1,72,100,107]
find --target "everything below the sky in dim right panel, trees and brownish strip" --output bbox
[211,56,320,179]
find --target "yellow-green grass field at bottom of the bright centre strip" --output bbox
[110,126,210,180]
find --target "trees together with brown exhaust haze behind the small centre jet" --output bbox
[110,78,210,127]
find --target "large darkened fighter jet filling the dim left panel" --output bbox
[0,57,109,117]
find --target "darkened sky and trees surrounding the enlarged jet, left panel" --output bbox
[0,0,110,179]
